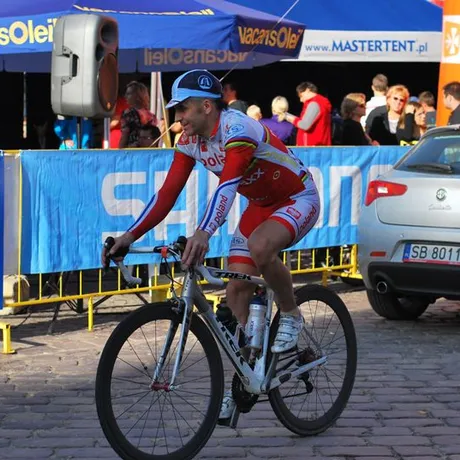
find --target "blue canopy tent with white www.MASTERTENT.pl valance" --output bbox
[232,0,442,62]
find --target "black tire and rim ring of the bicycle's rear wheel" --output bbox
[268,285,357,436]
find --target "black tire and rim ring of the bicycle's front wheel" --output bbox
[96,302,224,460]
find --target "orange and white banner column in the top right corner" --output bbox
[436,0,460,126]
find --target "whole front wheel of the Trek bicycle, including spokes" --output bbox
[96,302,224,460]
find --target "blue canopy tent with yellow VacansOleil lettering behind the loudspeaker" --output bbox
[0,0,304,72]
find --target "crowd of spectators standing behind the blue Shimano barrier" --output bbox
[29,74,460,150]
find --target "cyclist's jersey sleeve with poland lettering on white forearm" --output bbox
[198,126,258,235]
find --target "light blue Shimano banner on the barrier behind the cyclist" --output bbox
[21,147,408,273]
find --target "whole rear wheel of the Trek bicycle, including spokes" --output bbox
[268,285,357,436]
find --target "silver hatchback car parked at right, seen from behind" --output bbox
[358,125,460,319]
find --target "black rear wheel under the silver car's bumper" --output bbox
[367,289,431,320]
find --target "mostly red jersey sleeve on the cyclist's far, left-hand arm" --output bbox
[128,150,195,240]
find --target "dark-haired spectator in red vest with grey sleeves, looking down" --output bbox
[286,82,332,147]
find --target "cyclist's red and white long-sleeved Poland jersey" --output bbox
[129,109,317,239]
